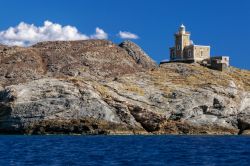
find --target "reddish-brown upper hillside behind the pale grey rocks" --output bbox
[0,40,156,86]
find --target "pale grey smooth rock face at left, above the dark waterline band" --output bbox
[0,79,144,133]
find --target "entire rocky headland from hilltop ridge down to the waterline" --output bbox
[0,40,250,134]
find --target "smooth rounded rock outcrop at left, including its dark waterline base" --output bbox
[0,79,145,134]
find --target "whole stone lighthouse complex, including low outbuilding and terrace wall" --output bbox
[166,24,229,71]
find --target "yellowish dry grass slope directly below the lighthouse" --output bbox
[149,64,250,91]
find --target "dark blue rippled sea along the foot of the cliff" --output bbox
[0,135,250,166]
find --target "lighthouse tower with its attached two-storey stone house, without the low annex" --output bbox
[170,24,210,62]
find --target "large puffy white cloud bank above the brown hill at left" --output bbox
[0,21,108,46]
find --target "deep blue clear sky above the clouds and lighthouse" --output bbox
[0,0,250,69]
